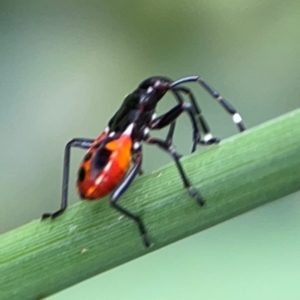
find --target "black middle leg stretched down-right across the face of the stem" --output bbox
[145,127,205,206]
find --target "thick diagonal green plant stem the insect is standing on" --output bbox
[0,109,300,300]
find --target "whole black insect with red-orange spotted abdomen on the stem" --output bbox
[42,76,245,247]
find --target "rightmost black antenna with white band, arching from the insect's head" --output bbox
[170,76,246,131]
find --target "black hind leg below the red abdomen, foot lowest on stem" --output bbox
[110,148,150,247]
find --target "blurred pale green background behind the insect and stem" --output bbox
[0,0,300,300]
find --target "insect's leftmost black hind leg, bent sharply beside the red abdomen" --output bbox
[42,138,94,220]
